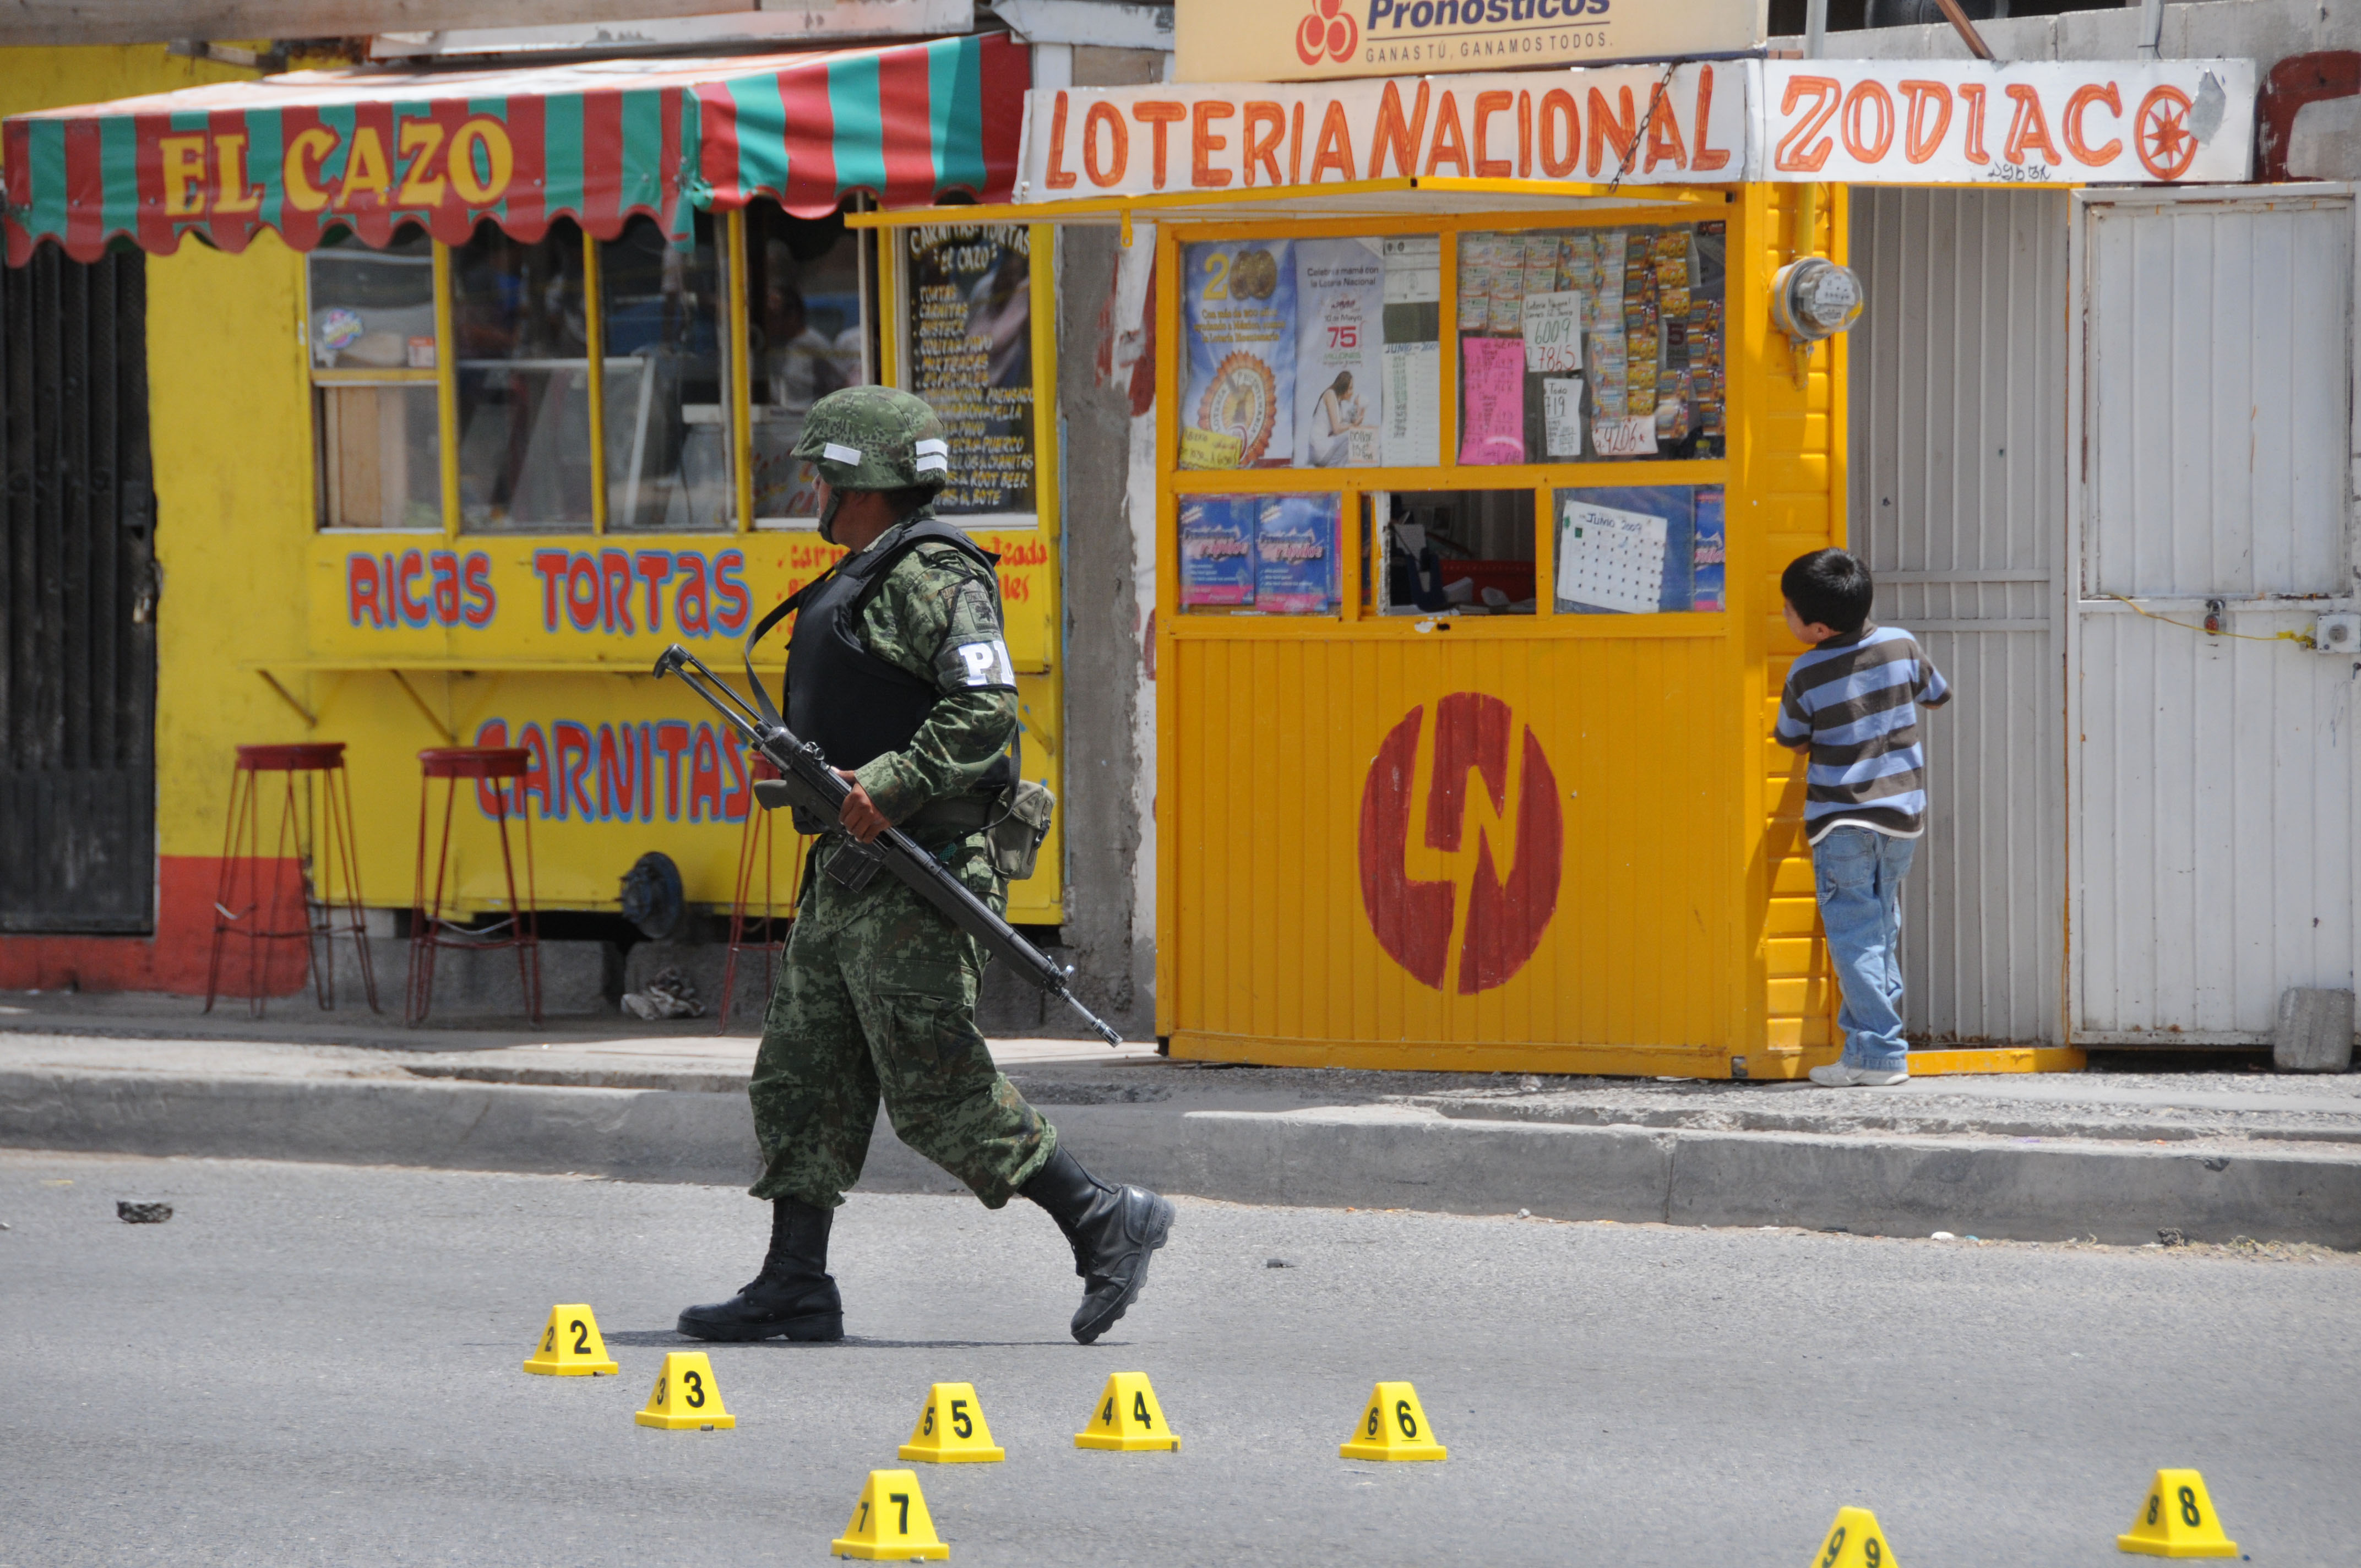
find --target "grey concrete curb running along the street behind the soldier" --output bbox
[0,1070,2361,1249]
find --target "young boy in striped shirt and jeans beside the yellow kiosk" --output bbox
[1778,550,1950,1088]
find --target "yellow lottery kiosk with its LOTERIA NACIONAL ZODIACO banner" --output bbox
[855,48,2253,1079]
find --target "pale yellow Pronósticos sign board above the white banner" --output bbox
[1173,0,1766,83]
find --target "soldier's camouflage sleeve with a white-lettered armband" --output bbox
[855,546,1018,822]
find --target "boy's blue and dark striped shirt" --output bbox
[1776,623,1950,843]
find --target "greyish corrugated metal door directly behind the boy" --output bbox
[1846,187,2068,1046]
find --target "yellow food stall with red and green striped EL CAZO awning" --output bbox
[0,33,1065,1006]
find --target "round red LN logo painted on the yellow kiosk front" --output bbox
[1360,692,1565,997]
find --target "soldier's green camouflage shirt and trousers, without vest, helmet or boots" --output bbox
[751,508,1058,1209]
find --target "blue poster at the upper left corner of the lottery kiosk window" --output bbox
[1180,241,1303,467]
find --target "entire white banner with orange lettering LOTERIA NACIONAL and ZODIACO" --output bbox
[1018,59,2255,201]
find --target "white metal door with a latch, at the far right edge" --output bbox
[2066,187,2361,1046]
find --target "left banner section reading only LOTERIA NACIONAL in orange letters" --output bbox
[1018,62,1749,201]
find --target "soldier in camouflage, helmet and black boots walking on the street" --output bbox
[680,387,1173,1344]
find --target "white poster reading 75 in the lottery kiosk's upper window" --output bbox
[1294,238,1386,467]
